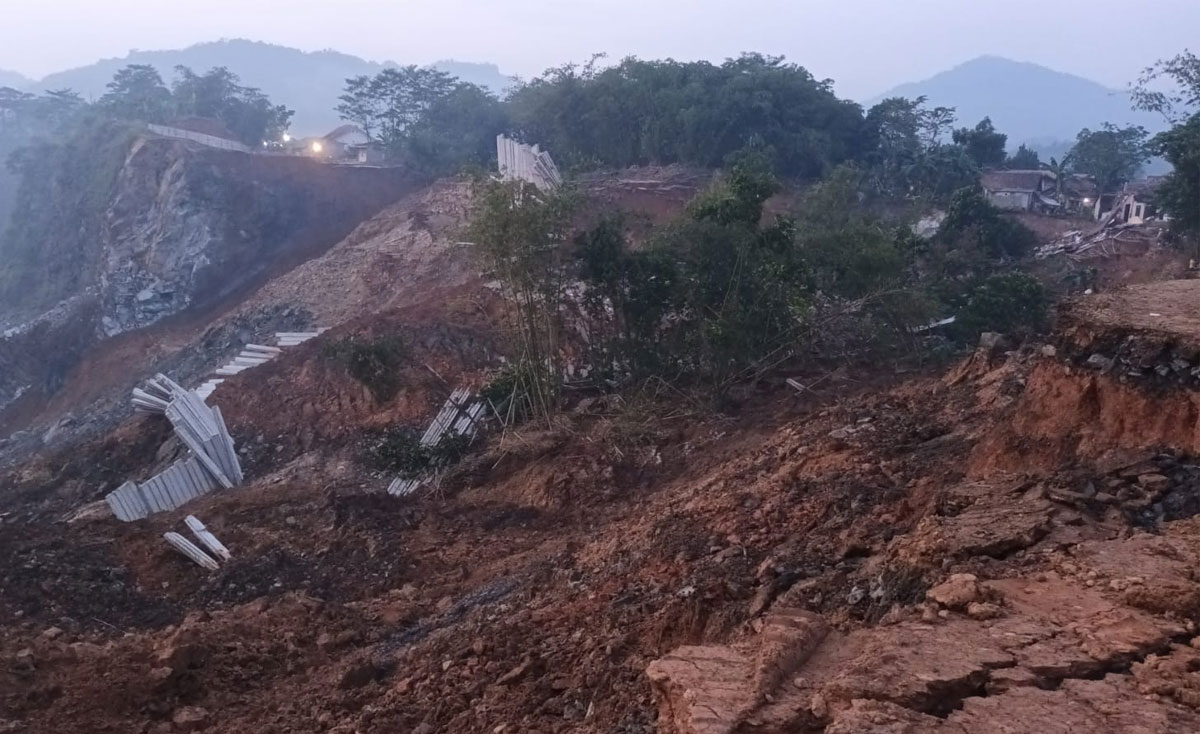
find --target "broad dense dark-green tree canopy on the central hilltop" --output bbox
[509,54,863,178]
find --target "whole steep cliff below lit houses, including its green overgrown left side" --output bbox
[0,128,414,426]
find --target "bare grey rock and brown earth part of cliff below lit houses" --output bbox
[94,138,408,336]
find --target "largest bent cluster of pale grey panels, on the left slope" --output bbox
[104,374,245,522]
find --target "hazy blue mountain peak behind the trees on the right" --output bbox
[865,56,1163,157]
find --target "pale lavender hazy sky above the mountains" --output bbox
[0,0,1200,98]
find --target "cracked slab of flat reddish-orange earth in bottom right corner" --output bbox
[648,485,1200,734]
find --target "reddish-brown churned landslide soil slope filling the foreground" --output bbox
[7,277,1200,734]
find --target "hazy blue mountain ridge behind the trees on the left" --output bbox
[9,40,515,136]
